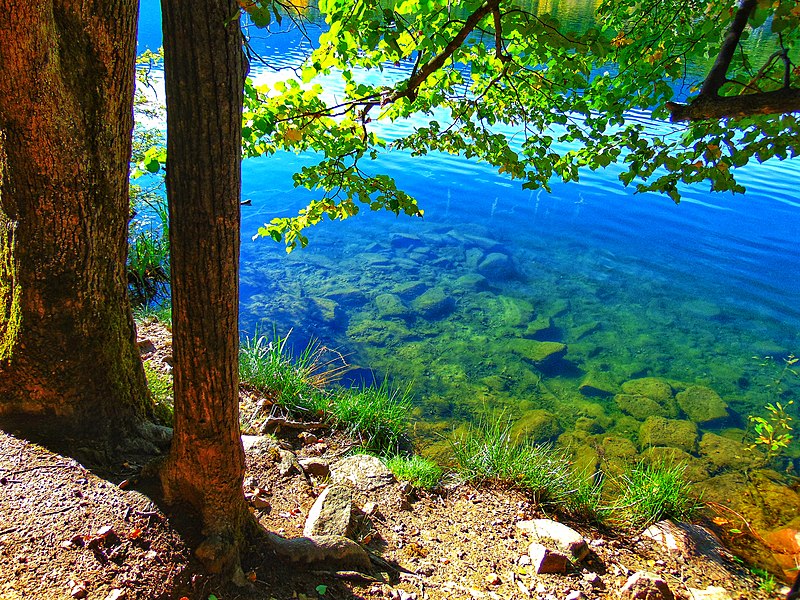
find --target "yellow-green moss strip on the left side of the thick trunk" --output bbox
[0,218,22,363]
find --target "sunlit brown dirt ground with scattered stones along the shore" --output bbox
[0,324,779,600]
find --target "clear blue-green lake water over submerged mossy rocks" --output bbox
[140,2,800,536]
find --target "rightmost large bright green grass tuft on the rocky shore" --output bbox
[611,462,702,529]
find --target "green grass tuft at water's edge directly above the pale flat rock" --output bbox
[331,379,411,453]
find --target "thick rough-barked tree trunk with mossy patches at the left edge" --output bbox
[0,0,153,442]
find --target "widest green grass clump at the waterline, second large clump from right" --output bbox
[452,417,570,502]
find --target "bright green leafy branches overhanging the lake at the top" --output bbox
[243,0,800,250]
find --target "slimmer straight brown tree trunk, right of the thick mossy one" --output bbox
[161,0,254,574]
